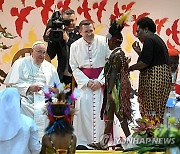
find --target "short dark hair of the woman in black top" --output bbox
[137,17,156,33]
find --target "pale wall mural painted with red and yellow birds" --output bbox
[0,0,180,89]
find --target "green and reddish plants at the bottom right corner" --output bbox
[124,117,180,154]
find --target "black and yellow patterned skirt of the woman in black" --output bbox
[138,64,172,118]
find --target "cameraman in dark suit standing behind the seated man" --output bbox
[43,9,81,84]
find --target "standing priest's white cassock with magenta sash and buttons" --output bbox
[70,35,110,146]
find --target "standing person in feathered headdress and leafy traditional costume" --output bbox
[90,12,131,149]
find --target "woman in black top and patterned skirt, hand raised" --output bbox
[129,17,171,123]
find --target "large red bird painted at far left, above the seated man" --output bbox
[10,6,34,37]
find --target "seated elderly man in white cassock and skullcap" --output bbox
[4,41,63,140]
